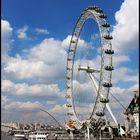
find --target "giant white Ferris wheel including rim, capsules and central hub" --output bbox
[66,6,114,138]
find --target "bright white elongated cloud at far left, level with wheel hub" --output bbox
[3,57,49,79]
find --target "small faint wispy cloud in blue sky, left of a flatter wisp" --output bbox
[17,25,28,39]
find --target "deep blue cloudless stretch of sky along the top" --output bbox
[2,0,122,43]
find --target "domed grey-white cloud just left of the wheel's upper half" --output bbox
[28,38,67,65]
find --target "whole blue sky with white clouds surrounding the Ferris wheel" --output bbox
[1,0,138,122]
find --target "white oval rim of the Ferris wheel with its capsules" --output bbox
[66,7,113,129]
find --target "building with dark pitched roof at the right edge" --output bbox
[124,91,139,137]
